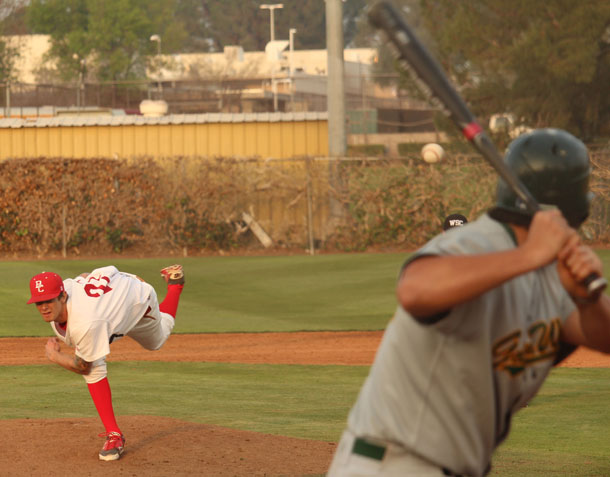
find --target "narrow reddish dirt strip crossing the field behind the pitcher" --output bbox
[0,331,610,368]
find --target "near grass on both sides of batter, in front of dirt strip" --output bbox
[0,362,610,477]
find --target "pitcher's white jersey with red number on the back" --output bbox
[51,266,154,362]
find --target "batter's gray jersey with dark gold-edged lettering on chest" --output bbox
[348,215,574,476]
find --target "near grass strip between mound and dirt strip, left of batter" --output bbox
[0,361,368,441]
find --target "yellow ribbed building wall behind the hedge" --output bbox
[0,119,328,159]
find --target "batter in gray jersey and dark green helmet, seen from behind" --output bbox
[328,129,610,477]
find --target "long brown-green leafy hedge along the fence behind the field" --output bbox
[0,152,610,256]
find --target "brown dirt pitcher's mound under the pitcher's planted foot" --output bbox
[0,416,335,477]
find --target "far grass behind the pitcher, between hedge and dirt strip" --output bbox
[0,254,407,336]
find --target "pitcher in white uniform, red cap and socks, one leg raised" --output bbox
[28,265,184,461]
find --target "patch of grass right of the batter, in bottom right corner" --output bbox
[491,368,610,477]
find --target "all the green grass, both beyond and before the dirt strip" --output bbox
[0,250,610,477]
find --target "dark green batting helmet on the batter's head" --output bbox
[492,128,593,228]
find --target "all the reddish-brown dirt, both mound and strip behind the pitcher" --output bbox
[0,332,610,477]
